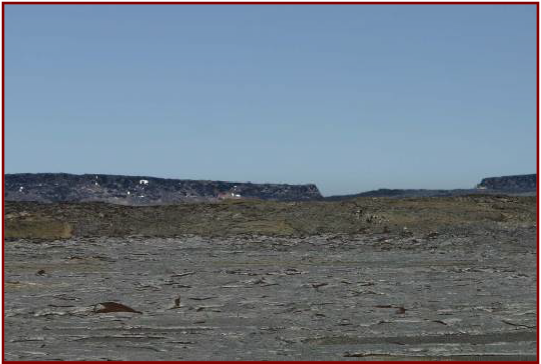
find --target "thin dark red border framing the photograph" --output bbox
[1,1,540,363]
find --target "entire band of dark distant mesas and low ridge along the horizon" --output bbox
[4,173,537,205]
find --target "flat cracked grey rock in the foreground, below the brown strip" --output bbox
[5,229,537,360]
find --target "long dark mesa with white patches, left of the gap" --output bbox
[4,173,322,205]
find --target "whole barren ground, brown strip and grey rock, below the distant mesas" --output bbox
[4,196,537,360]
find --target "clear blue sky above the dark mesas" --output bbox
[5,5,536,195]
